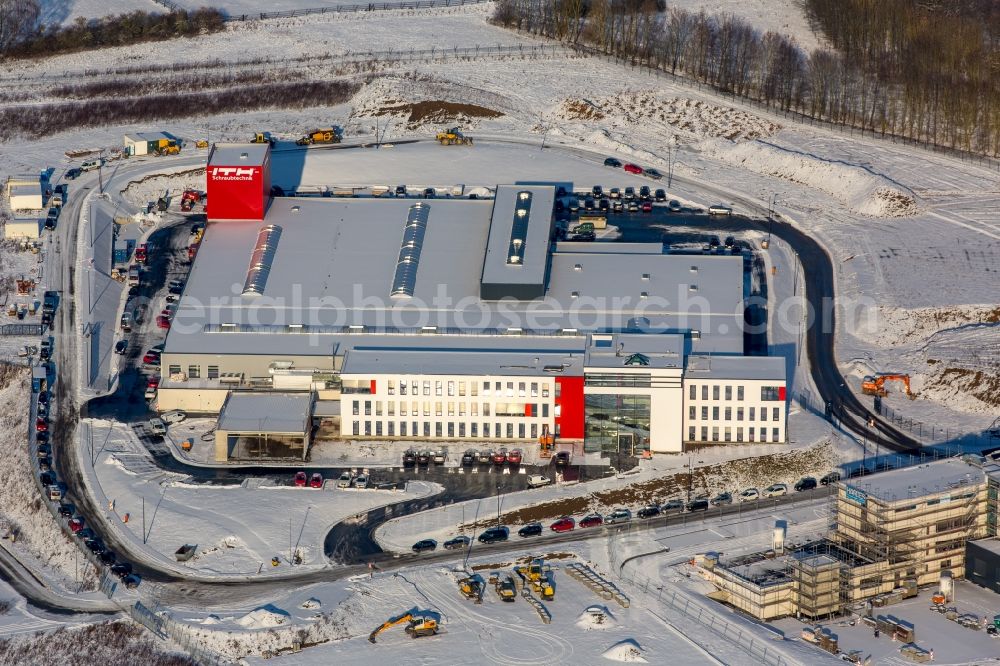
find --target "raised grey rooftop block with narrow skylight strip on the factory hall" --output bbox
[480,185,555,301]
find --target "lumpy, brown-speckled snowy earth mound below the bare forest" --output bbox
[552,91,781,141]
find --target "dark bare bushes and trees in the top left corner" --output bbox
[0,0,225,58]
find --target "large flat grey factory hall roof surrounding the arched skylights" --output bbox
[166,192,743,355]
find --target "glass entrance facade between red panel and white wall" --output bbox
[584,394,649,455]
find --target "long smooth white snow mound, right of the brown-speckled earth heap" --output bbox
[701,141,917,217]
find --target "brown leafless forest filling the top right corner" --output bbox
[493,0,1000,156]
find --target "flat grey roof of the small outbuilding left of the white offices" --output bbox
[218,392,312,434]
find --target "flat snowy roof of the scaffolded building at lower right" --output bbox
[840,458,985,502]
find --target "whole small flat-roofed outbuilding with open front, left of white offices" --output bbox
[215,391,313,462]
